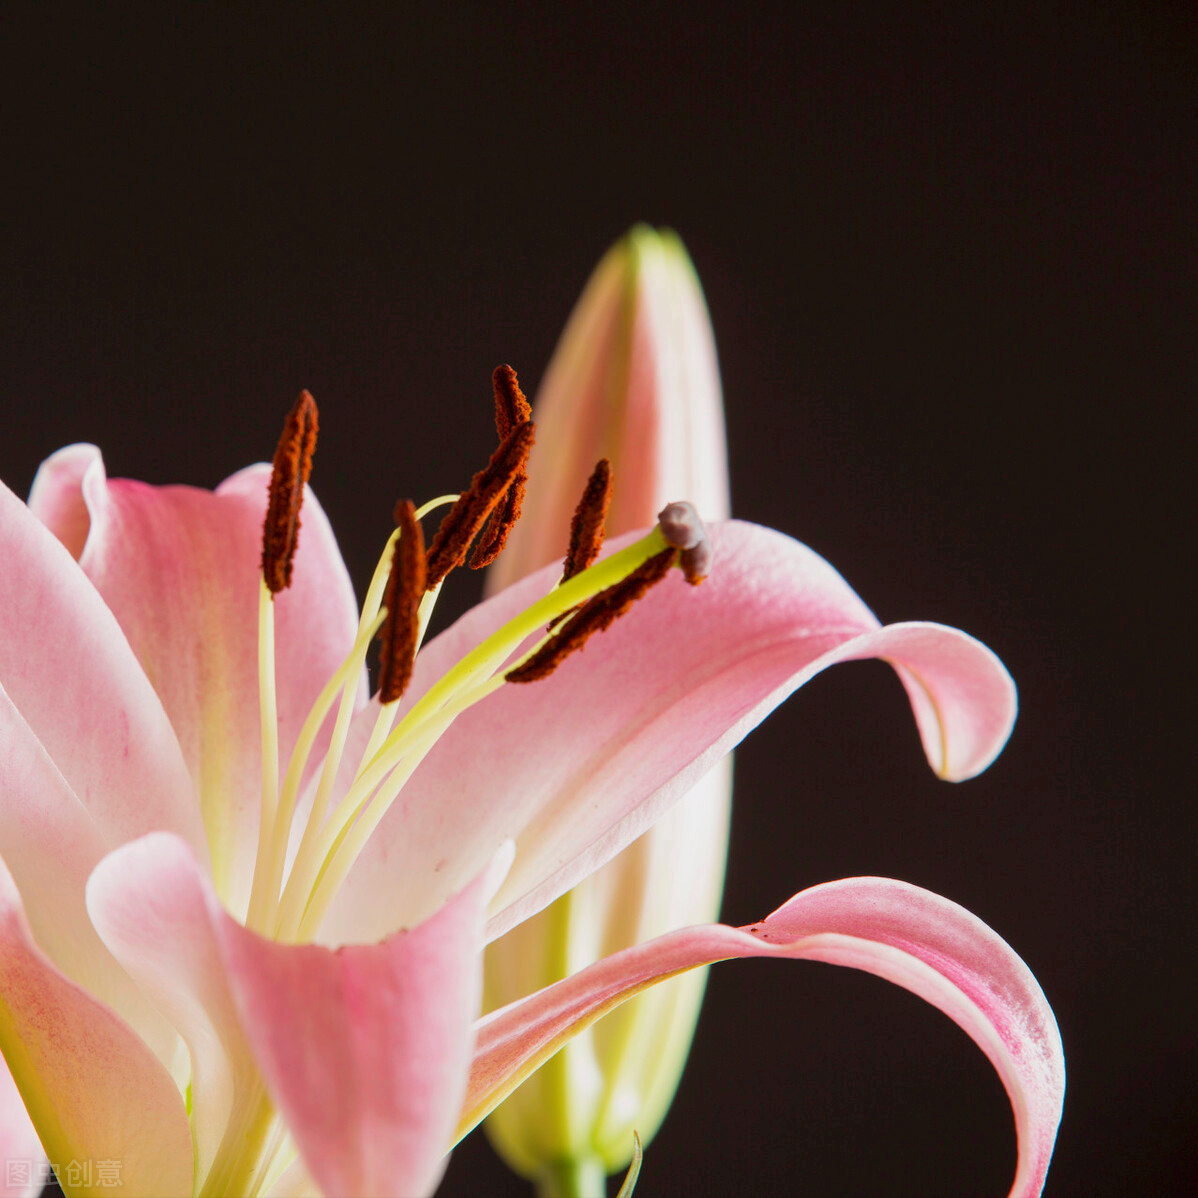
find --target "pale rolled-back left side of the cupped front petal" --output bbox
[87,833,261,1188]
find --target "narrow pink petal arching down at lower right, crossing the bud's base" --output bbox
[462,878,1065,1198]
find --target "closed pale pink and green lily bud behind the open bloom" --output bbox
[484,225,732,1193]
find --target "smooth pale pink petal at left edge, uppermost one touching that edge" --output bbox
[0,464,204,849]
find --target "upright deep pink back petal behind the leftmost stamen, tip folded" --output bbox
[30,446,365,913]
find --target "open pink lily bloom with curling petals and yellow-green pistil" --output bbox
[0,378,1064,1196]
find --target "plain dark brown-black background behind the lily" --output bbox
[0,2,1196,1196]
